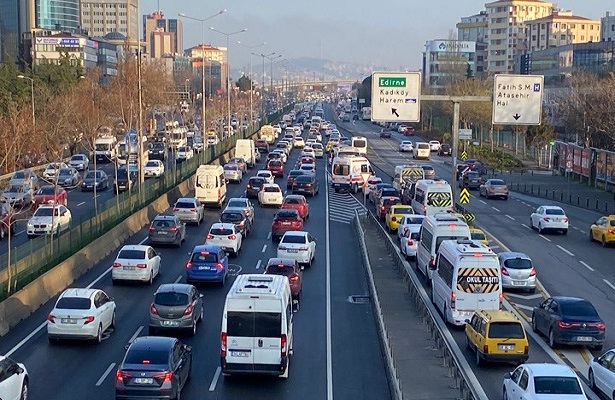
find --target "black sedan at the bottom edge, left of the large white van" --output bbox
[115,336,192,399]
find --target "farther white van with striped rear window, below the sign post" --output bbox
[412,179,453,215]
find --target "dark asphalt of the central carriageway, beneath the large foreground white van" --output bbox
[0,134,390,400]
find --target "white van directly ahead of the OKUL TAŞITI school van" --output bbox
[416,213,471,279]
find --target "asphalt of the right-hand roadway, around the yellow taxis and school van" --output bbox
[338,110,615,398]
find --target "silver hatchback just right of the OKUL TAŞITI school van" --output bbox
[498,251,536,293]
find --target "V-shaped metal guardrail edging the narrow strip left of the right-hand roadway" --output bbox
[353,212,488,400]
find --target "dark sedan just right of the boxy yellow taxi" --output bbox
[532,296,606,350]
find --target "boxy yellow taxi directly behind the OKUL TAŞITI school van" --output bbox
[465,310,530,366]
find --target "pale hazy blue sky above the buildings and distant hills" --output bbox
[139,0,615,70]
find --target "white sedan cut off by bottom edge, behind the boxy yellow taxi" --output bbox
[502,363,586,400]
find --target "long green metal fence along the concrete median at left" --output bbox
[0,104,293,301]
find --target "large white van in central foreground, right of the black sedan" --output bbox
[220,274,293,378]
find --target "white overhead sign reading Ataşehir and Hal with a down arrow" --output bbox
[492,74,544,125]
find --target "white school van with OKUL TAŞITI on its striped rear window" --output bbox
[431,240,502,326]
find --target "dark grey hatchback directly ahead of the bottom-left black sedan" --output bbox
[149,283,203,336]
